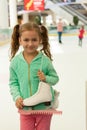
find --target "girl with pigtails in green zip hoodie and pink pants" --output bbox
[9,23,59,130]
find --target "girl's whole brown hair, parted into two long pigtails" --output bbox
[11,22,52,60]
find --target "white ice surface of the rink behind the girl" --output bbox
[0,36,87,130]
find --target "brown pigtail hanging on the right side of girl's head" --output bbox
[40,26,52,60]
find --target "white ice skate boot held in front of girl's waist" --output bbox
[23,81,52,106]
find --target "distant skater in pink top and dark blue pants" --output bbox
[57,18,63,43]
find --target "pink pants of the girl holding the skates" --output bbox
[20,114,52,130]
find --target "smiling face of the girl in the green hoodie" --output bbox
[19,30,41,54]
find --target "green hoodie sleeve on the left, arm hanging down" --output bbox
[9,66,21,101]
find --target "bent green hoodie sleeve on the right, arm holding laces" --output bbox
[46,61,59,85]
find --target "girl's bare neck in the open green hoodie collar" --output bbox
[23,51,39,64]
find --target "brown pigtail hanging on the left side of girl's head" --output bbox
[10,24,20,59]
